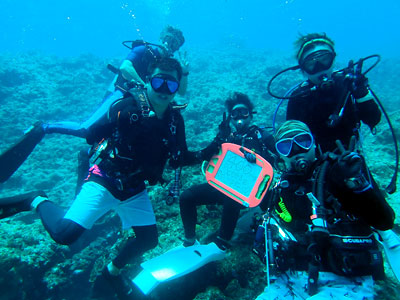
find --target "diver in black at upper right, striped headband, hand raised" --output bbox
[286,33,381,152]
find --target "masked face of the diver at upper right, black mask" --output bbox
[299,44,335,84]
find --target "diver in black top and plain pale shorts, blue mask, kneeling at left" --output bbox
[0,58,209,298]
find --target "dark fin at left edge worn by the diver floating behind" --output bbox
[0,122,45,183]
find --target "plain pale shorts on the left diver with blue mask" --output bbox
[64,181,156,229]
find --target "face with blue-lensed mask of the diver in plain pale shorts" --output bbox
[146,68,179,110]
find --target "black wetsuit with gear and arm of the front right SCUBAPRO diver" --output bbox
[260,160,394,276]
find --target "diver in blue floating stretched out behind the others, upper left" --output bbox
[0,25,189,182]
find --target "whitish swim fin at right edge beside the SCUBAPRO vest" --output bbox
[377,230,400,282]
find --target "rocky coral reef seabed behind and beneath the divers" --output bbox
[0,49,400,300]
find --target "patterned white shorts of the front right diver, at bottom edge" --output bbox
[256,272,374,300]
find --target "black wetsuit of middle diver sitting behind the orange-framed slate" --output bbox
[179,126,274,241]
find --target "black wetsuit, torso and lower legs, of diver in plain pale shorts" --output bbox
[30,89,209,268]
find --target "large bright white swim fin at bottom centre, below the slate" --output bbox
[133,243,226,295]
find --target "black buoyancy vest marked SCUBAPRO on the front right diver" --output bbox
[275,157,384,279]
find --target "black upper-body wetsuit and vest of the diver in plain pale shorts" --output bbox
[87,88,202,199]
